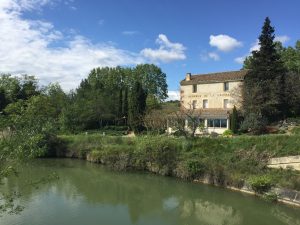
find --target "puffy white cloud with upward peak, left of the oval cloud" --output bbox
[141,34,186,63]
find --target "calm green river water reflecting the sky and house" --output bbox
[0,159,300,225]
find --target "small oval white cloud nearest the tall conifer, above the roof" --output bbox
[209,34,243,52]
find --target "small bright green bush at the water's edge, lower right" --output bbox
[248,175,274,194]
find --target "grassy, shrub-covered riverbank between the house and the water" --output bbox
[49,134,300,206]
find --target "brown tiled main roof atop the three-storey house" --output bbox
[180,70,249,85]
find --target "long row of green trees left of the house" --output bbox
[0,64,167,170]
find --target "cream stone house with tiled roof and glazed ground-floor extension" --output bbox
[171,70,248,134]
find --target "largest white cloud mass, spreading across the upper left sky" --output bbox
[0,0,145,90]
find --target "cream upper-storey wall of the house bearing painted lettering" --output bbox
[180,81,242,109]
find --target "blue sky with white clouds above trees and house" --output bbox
[0,0,300,99]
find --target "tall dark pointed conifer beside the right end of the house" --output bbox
[243,17,286,122]
